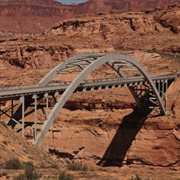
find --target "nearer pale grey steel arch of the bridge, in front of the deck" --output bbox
[35,54,165,146]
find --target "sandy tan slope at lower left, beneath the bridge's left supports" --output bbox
[0,121,56,169]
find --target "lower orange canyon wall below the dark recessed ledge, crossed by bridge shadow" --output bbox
[42,100,180,168]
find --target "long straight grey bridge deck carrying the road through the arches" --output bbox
[0,73,177,100]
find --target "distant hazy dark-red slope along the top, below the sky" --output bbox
[0,0,180,33]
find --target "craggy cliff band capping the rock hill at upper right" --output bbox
[46,5,180,39]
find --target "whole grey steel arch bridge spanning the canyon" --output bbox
[0,54,177,146]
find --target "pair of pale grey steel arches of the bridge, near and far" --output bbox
[35,54,165,146]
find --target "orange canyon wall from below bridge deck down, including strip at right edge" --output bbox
[42,77,180,170]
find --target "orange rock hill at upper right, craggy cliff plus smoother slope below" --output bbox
[46,5,180,53]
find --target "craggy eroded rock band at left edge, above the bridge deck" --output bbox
[0,41,74,68]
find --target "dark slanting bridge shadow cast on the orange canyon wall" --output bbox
[97,110,147,166]
